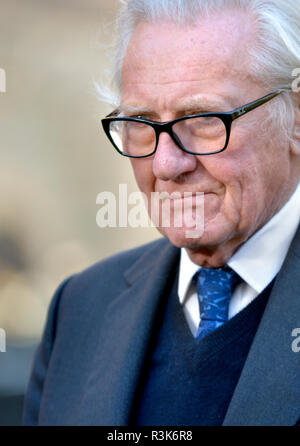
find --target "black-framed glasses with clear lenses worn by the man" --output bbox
[101,89,286,158]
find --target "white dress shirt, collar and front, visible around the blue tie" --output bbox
[178,183,300,336]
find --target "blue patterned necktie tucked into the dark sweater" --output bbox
[193,267,239,339]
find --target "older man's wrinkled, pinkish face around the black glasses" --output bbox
[121,13,296,267]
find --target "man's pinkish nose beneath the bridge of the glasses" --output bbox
[152,133,197,181]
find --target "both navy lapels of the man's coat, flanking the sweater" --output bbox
[78,225,300,426]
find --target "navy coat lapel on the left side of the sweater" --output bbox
[78,241,180,426]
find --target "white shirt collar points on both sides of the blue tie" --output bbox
[178,183,300,304]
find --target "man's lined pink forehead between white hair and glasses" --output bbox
[122,12,254,109]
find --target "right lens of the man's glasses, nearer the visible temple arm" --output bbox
[173,116,227,154]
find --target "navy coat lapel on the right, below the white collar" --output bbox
[223,230,300,426]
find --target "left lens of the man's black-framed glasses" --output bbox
[109,120,156,156]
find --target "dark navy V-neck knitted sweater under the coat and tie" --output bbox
[130,280,272,426]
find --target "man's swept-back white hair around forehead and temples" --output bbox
[98,0,300,139]
